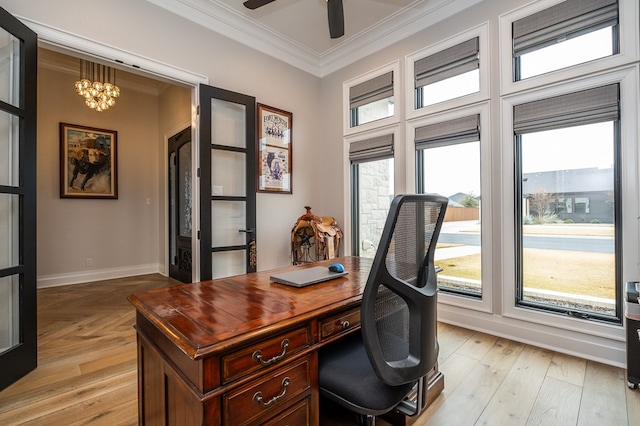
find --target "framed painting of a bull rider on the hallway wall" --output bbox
[60,123,118,199]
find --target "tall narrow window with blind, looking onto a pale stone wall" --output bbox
[349,134,394,258]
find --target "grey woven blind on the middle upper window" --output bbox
[413,37,480,89]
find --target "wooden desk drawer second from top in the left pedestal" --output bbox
[223,357,311,426]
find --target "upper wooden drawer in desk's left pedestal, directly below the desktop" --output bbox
[222,327,311,383]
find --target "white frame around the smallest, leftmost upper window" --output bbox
[342,61,402,136]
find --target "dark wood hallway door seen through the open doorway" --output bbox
[167,127,193,283]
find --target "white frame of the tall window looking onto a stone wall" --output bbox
[342,124,405,256]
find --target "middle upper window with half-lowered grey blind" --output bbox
[414,37,480,109]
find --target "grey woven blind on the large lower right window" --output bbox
[513,83,620,134]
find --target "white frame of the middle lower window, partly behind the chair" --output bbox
[404,101,493,313]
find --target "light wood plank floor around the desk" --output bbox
[0,275,640,426]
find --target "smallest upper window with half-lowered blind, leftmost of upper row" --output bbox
[349,71,394,127]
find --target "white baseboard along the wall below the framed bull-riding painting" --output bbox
[37,263,164,288]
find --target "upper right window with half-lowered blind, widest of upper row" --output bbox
[512,0,619,81]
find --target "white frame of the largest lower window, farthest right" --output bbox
[501,64,640,341]
